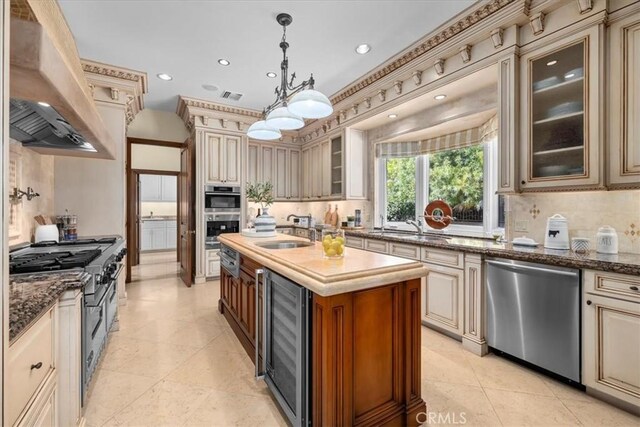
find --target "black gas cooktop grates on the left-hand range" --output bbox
[9,249,102,274]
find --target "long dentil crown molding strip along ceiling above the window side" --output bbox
[331,0,517,105]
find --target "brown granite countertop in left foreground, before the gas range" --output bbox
[9,270,91,342]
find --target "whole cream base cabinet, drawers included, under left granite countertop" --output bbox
[4,306,58,426]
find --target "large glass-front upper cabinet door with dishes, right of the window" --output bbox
[520,27,604,191]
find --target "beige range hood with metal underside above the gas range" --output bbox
[10,15,115,159]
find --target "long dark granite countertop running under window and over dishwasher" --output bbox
[345,230,640,276]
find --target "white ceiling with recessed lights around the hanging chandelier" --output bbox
[59,0,474,111]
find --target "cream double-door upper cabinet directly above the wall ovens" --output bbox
[204,132,242,185]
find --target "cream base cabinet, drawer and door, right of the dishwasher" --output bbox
[582,270,640,410]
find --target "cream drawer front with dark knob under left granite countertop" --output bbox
[5,307,56,425]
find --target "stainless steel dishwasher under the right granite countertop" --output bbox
[486,259,580,383]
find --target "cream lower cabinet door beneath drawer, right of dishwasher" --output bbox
[582,294,640,405]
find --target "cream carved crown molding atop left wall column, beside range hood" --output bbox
[80,59,148,125]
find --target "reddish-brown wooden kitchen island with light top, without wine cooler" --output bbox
[219,234,428,426]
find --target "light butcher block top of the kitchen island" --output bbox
[218,233,428,296]
